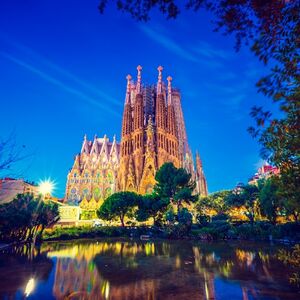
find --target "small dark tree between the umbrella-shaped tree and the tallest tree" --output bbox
[136,193,169,224]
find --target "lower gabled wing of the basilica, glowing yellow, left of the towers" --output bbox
[65,136,120,210]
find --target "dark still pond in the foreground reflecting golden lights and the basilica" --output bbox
[0,239,300,300]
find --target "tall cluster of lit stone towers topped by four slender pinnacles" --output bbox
[118,66,204,194]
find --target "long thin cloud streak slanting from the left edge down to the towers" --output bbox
[0,51,119,116]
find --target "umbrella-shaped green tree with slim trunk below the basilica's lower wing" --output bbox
[97,192,140,227]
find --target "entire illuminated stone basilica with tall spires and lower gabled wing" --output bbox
[65,66,207,209]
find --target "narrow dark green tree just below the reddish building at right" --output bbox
[259,177,283,224]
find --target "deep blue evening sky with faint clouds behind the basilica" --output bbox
[0,0,269,197]
